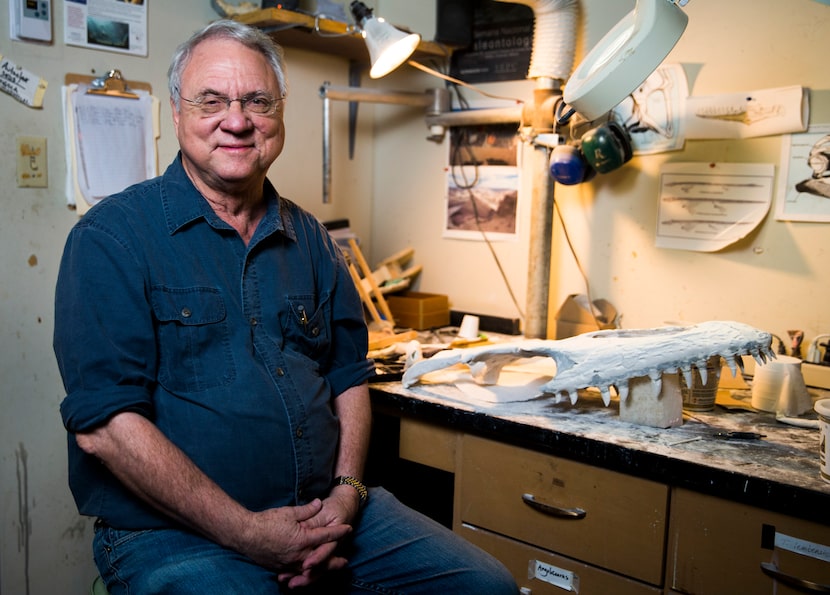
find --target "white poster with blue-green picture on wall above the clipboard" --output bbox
[63,0,147,56]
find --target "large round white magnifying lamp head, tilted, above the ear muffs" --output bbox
[563,0,689,120]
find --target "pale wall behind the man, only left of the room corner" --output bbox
[0,0,373,595]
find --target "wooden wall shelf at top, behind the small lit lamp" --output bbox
[234,8,450,62]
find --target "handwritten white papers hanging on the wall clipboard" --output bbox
[63,73,159,214]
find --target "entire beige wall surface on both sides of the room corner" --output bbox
[0,0,830,595]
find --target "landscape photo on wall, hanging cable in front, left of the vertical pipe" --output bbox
[444,124,519,240]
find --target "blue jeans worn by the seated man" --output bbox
[93,488,518,595]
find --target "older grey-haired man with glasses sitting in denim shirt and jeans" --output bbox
[55,21,516,595]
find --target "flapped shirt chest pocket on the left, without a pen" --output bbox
[152,287,236,392]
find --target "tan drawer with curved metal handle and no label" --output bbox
[453,435,669,585]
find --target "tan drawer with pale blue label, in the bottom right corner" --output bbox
[666,489,830,595]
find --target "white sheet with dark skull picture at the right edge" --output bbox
[775,124,830,223]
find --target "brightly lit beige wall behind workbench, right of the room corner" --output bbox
[372,0,830,352]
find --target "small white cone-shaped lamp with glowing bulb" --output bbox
[349,0,421,79]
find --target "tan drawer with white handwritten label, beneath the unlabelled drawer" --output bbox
[458,525,662,595]
